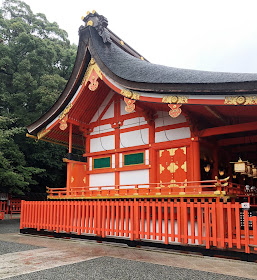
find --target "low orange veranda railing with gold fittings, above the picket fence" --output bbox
[47,178,252,199]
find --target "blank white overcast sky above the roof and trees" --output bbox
[0,0,257,73]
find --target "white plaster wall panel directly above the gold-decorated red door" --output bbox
[155,127,191,143]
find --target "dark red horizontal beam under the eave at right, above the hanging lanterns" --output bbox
[199,122,257,137]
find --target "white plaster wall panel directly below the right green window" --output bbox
[120,169,149,188]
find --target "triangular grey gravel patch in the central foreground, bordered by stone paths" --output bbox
[5,257,249,280]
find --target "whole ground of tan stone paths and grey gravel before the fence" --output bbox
[0,220,257,280]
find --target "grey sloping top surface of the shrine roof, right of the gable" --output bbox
[90,27,257,84]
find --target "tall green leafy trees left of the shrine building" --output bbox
[0,0,77,193]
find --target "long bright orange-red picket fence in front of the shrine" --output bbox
[20,198,257,253]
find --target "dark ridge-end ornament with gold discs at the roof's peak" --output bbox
[80,10,112,43]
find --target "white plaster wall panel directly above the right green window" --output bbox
[120,128,149,148]
